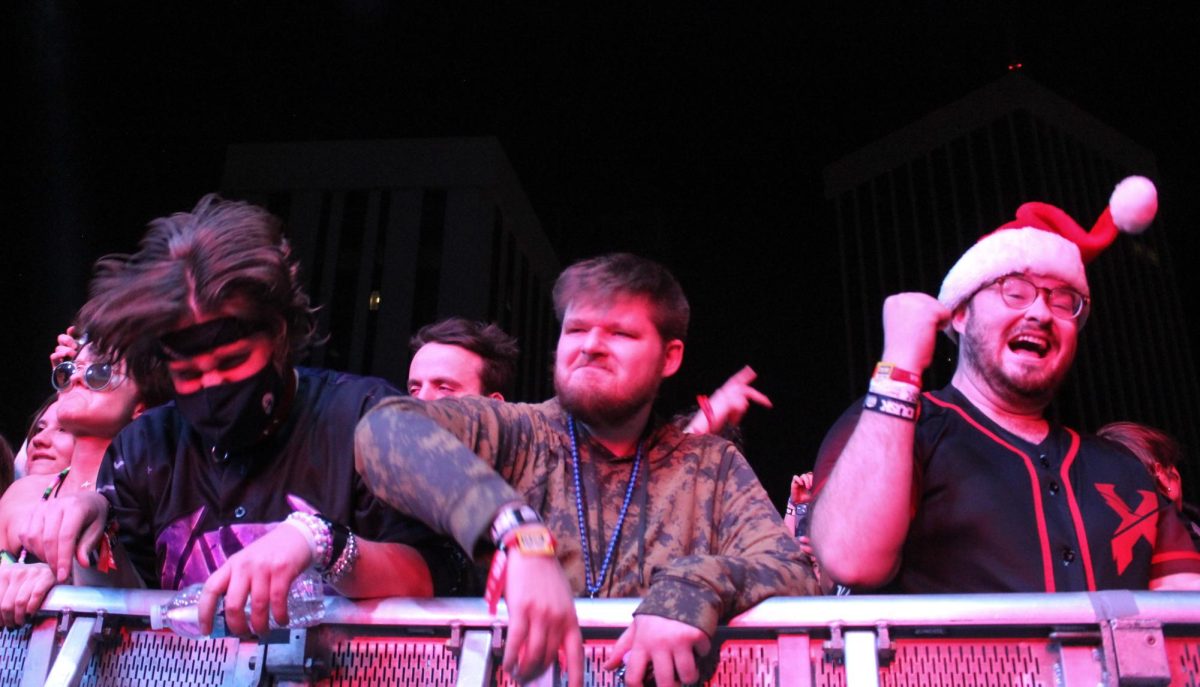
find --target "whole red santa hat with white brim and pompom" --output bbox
[937,177,1158,321]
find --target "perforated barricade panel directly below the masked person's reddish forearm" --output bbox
[329,638,458,687]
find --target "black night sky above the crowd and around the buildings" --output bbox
[0,0,1200,496]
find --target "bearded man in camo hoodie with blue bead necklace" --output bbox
[355,255,816,686]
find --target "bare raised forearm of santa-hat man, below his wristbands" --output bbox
[812,412,916,587]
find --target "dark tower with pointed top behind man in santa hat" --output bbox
[824,73,1200,449]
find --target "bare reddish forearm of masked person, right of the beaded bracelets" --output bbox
[334,538,433,598]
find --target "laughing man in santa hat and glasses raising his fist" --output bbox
[812,177,1200,593]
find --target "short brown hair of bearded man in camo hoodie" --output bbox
[553,253,691,341]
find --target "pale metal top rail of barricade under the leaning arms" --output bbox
[42,586,1200,629]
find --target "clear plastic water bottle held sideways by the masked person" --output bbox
[150,570,325,639]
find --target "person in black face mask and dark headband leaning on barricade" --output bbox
[25,196,466,634]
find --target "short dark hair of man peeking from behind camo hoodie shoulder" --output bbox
[408,317,521,398]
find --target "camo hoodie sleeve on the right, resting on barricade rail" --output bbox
[635,444,820,635]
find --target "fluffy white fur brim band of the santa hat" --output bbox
[937,227,1091,311]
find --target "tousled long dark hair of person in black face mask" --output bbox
[77,193,316,393]
